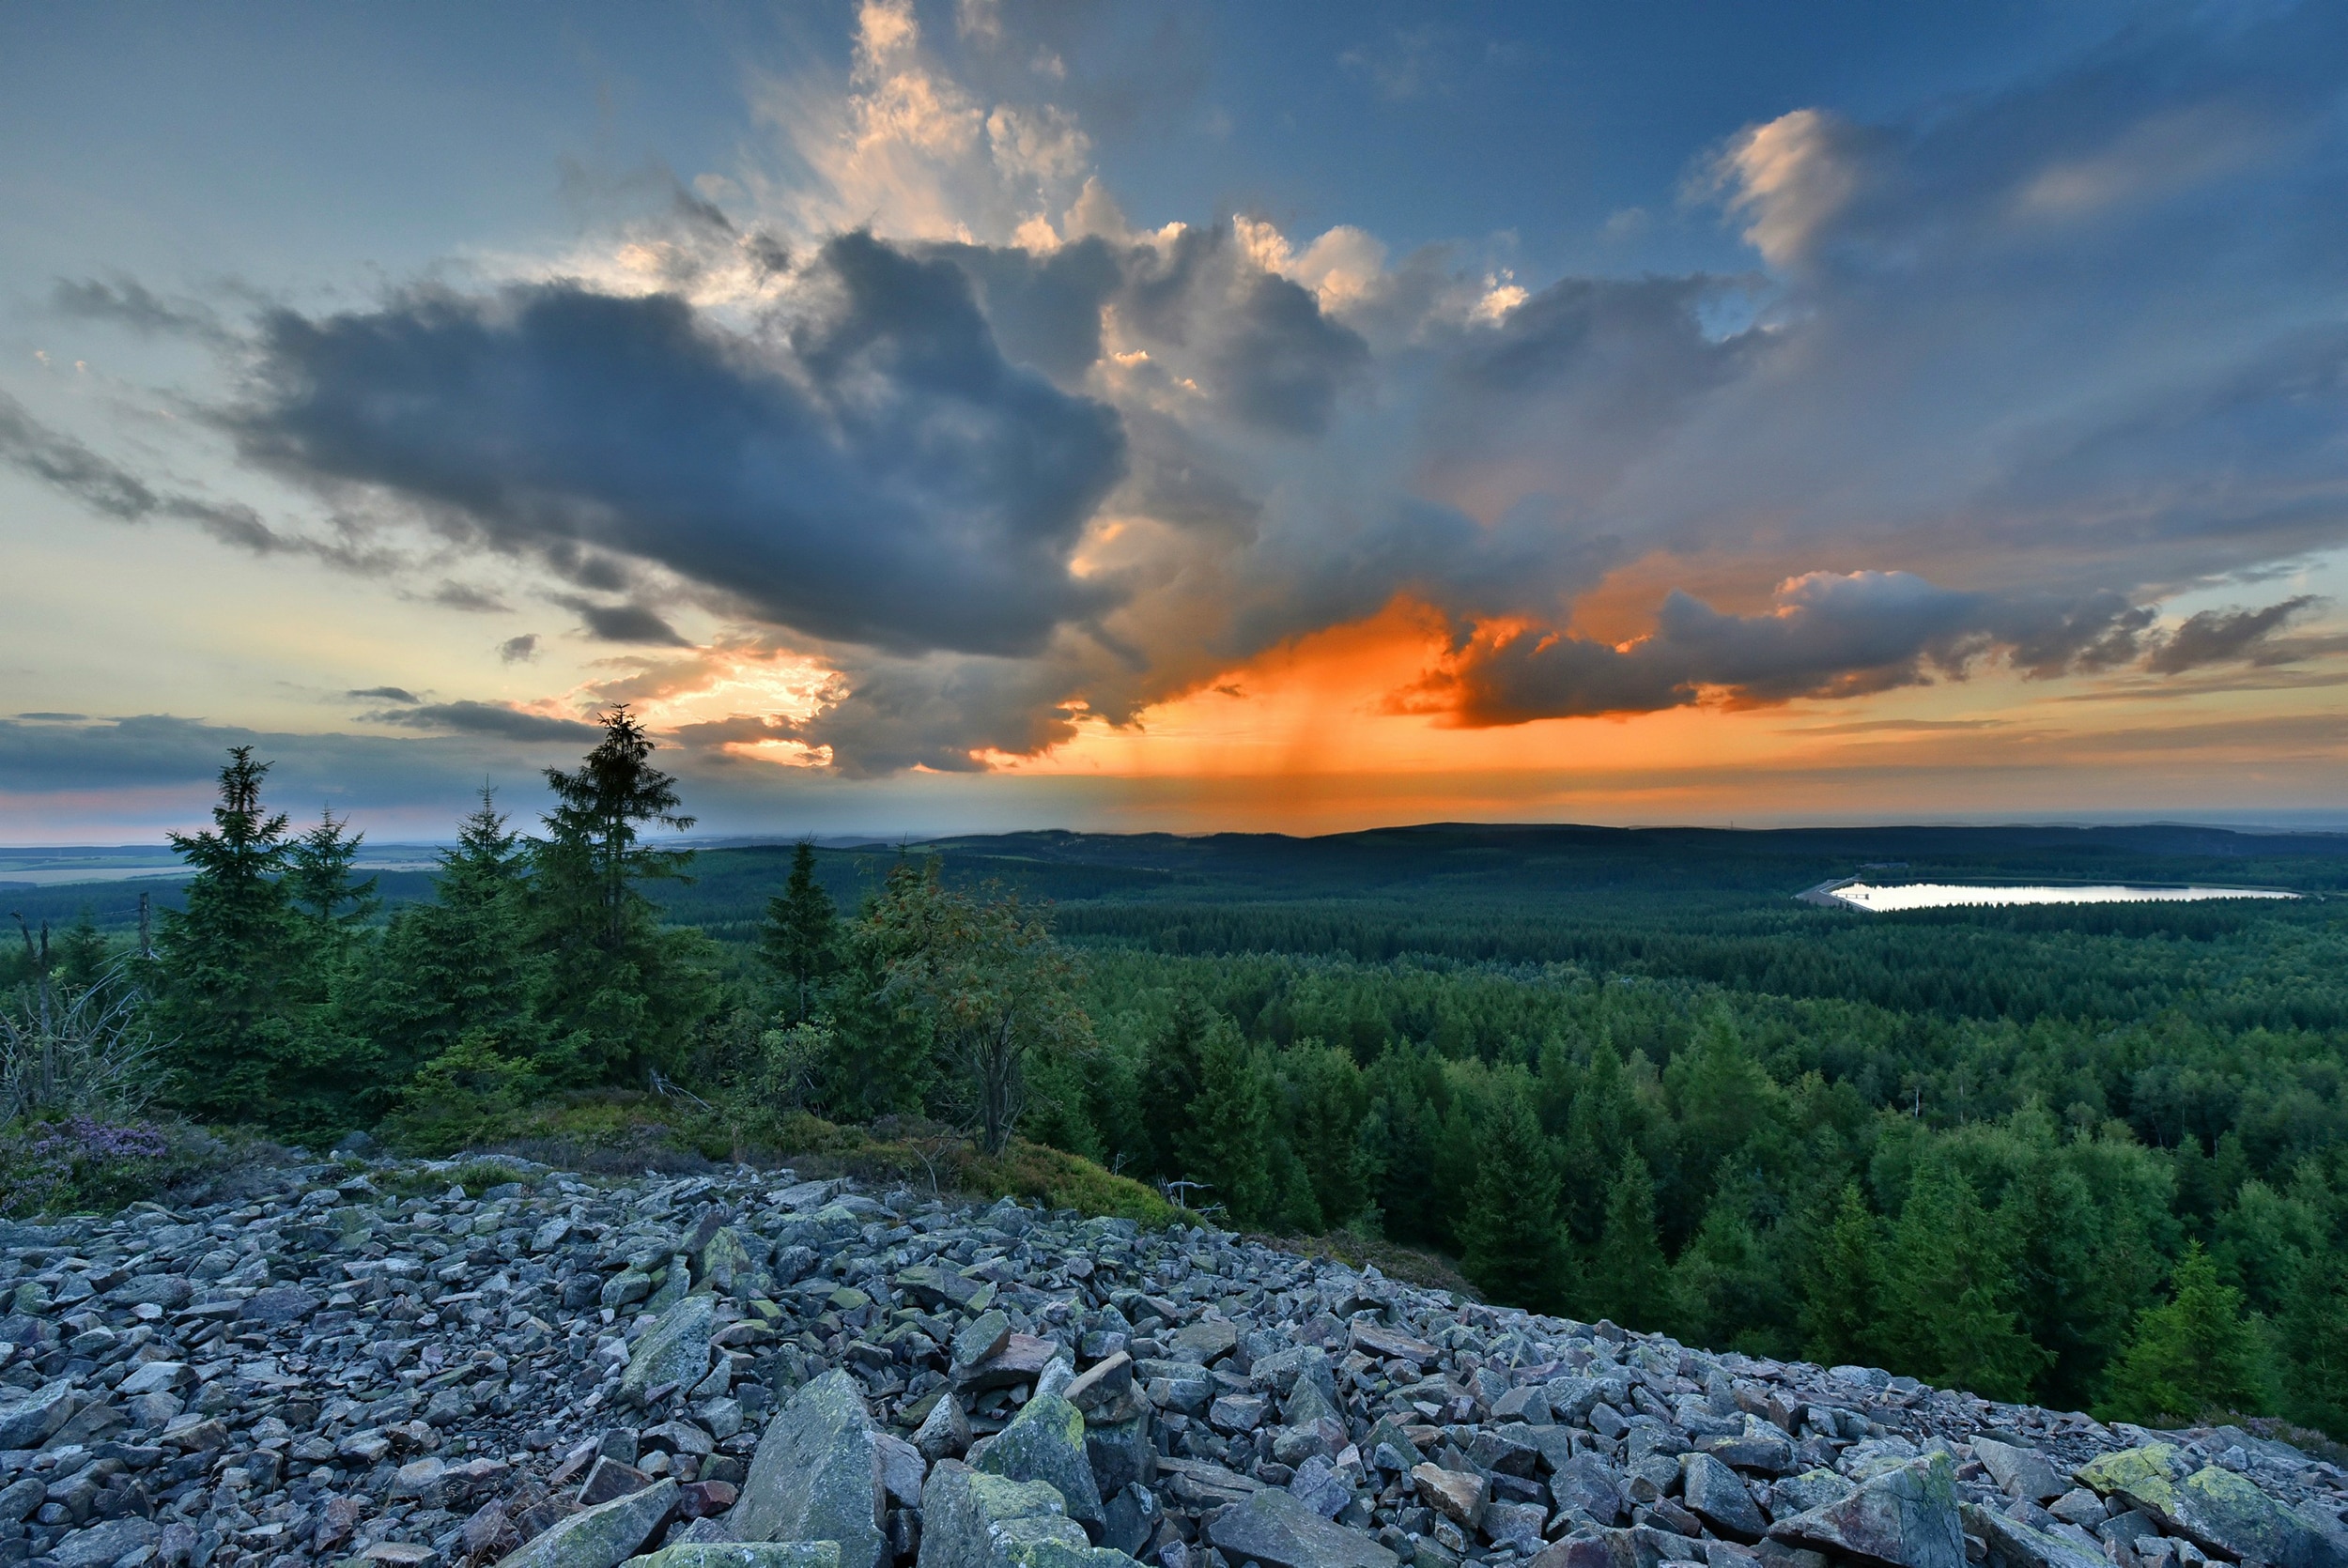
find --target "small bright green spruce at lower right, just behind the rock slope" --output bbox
[2107,1242,2273,1427]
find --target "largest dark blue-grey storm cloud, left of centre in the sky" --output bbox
[233,235,1125,653]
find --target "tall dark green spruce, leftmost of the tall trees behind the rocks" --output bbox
[155,746,305,1122]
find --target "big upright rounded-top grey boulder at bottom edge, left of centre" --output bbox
[728,1371,890,1568]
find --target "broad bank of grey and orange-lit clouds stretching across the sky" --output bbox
[13,5,2348,775]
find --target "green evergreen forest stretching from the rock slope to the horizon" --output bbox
[0,709,2348,1439]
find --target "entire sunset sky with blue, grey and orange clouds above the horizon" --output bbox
[0,0,2348,845]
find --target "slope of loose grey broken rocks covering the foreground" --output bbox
[0,1164,2348,1568]
